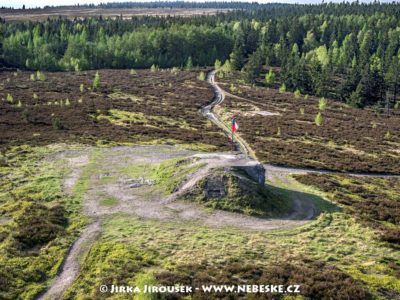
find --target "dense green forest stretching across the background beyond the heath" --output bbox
[0,2,400,107]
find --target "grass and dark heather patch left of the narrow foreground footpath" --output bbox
[0,145,93,299]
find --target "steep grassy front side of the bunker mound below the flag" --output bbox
[183,167,289,217]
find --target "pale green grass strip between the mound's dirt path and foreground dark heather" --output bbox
[66,212,400,299]
